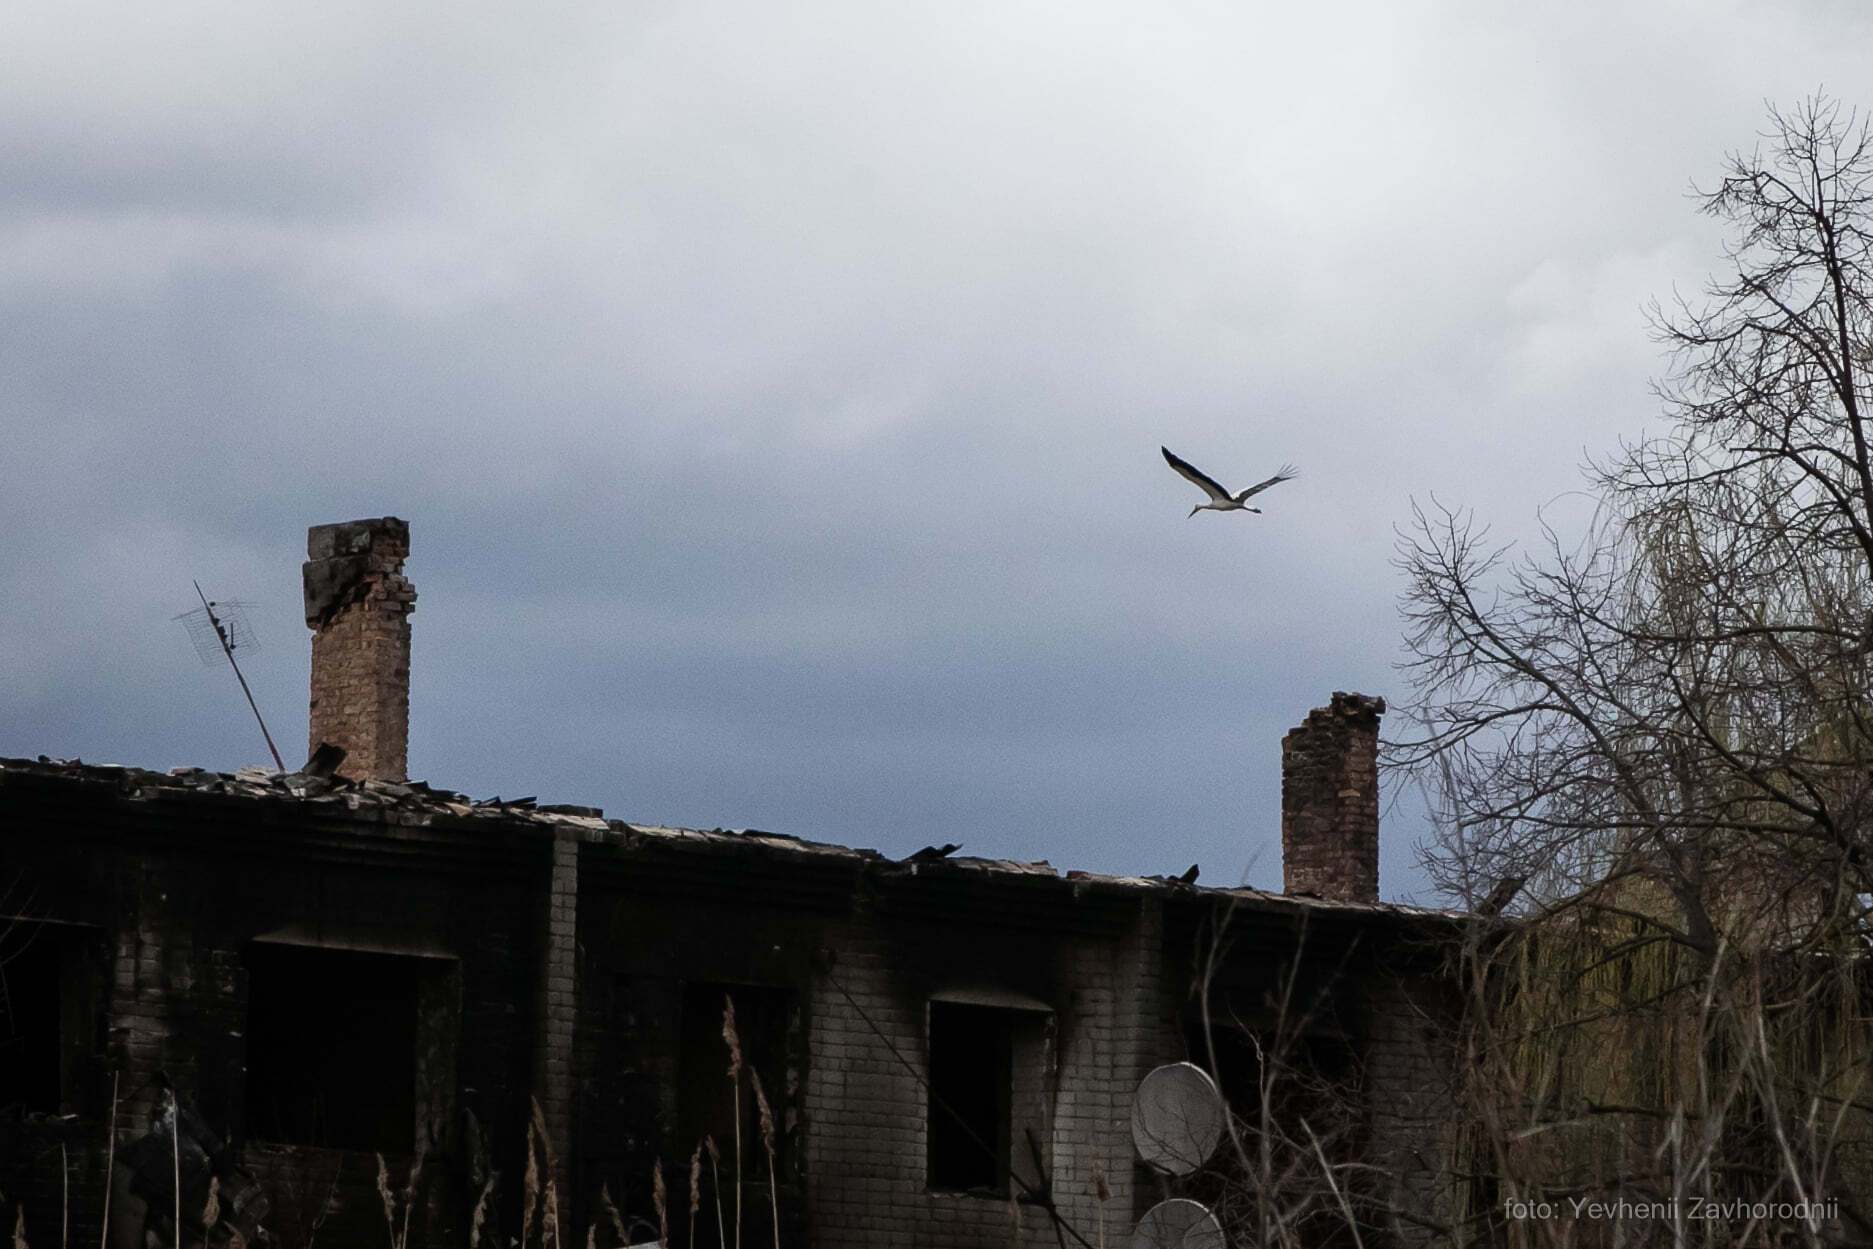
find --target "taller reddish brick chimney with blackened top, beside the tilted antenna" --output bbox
[305,517,416,781]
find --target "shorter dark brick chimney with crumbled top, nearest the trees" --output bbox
[1281,693,1386,903]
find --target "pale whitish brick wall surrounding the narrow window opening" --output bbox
[805,898,1156,1249]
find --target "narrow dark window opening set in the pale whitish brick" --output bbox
[927,1002,1015,1195]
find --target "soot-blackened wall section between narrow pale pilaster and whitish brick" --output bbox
[573,843,842,1245]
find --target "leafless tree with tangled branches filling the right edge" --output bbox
[1388,97,1873,1243]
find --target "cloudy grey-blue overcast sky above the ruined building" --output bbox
[0,0,1873,897]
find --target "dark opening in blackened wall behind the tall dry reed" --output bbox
[674,981,800,1183]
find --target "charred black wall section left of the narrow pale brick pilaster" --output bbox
[0,777,541,1243]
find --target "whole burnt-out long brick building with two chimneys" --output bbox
[0,519,1457,1249]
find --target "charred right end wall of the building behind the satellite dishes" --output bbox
[1161,893,1459,1245]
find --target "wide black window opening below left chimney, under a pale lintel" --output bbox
[245,944,420,1153]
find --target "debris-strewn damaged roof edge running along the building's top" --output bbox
[0,755,1467,919]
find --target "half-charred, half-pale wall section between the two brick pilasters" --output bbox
[573,846,1156,1249]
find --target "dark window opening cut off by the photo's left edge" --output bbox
[0,919,82,1114]
